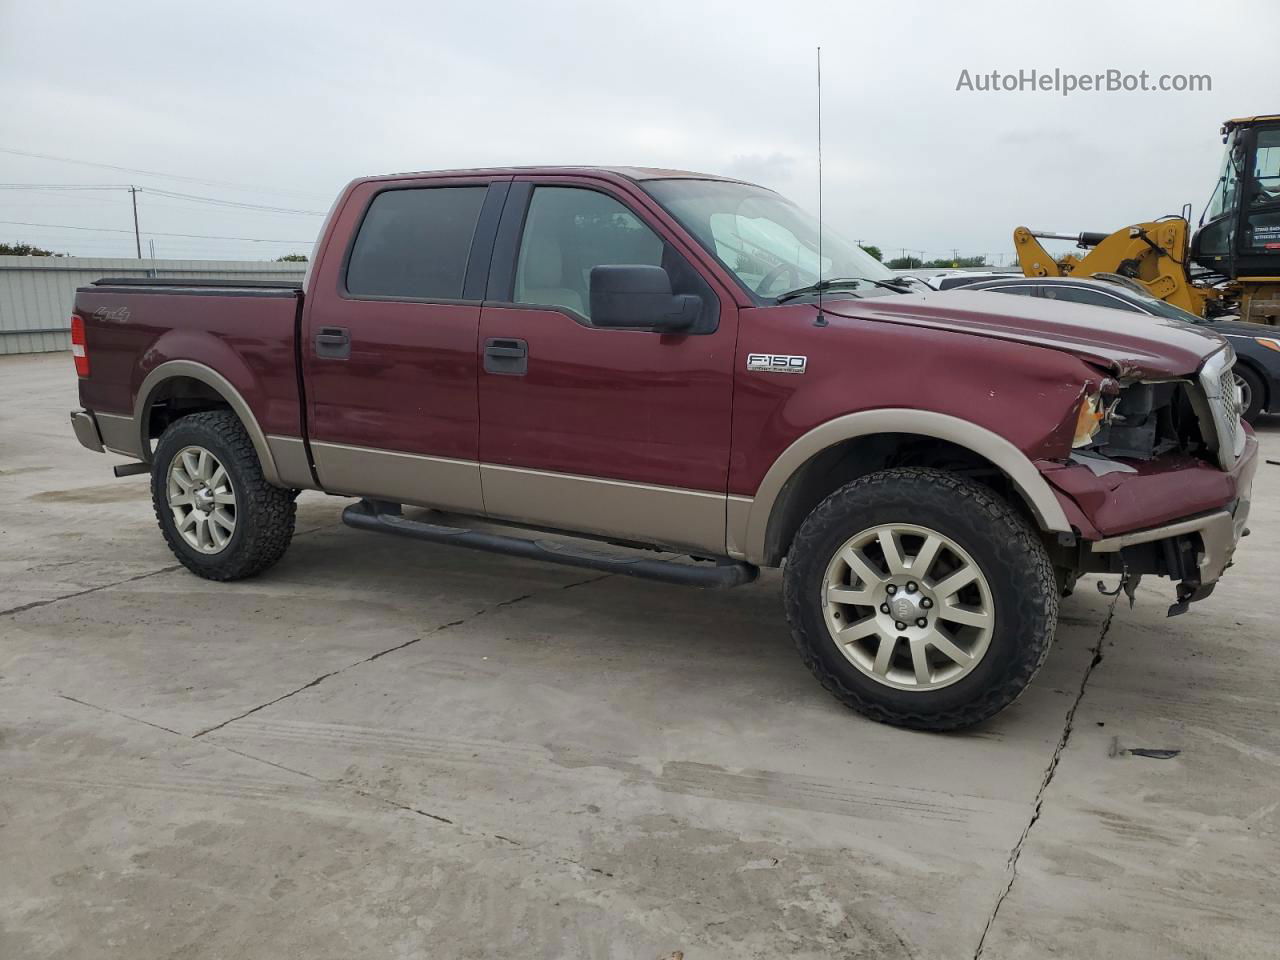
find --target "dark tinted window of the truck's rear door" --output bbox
[347,187,486,300]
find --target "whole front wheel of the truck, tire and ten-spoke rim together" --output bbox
[783,467,1059,731]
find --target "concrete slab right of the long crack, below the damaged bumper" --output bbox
[983,424,1280,960]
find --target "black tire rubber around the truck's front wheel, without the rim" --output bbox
[783,467,1059,731]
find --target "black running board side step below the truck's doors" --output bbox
[342,500,760,586]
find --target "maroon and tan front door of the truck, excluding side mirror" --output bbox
[479,177,737,556]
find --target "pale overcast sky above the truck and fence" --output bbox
[0,0,1280,259]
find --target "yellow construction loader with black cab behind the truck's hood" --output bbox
[1014,114,1280,324]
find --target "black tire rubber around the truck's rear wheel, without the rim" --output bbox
[151,411,297,580]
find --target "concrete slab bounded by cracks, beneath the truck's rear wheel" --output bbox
[4,519,582,733]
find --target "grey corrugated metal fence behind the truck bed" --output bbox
[0,256,307,353]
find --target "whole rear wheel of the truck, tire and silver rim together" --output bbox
[151,411,297,580]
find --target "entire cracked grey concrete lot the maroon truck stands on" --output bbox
[0,356,1280,960]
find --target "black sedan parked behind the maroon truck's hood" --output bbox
[963,276,1280,424]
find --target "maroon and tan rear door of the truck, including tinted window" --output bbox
[301,177,509,513]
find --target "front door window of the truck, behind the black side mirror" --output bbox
[512,187,719,333]
